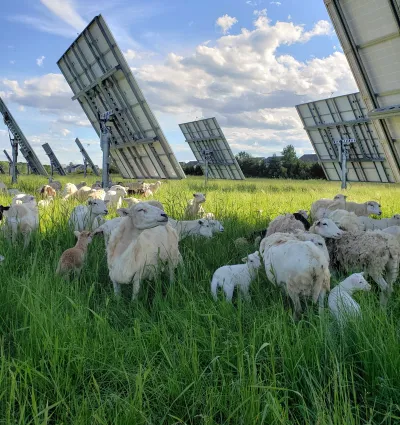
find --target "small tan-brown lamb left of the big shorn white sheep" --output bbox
[56,230,92,279]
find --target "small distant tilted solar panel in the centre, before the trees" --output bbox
[179,118,244,180]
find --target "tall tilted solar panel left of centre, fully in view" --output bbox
[57,15,185,180]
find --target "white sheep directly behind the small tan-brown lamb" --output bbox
[68,199,108,232]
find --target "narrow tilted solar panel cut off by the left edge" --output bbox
[0,98,47,176]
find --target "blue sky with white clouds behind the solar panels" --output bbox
[0,0,357,164]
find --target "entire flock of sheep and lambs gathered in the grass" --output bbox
[0,182,400,320]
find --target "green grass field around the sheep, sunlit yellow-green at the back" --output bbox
[0,177,400,425]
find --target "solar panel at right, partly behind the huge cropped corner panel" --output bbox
[296,93,395,183]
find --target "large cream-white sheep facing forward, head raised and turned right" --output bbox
[107,202,182,300]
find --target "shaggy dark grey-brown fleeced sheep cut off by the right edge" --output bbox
[314,219,400,306]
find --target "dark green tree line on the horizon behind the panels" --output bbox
[183,145,326,180]
